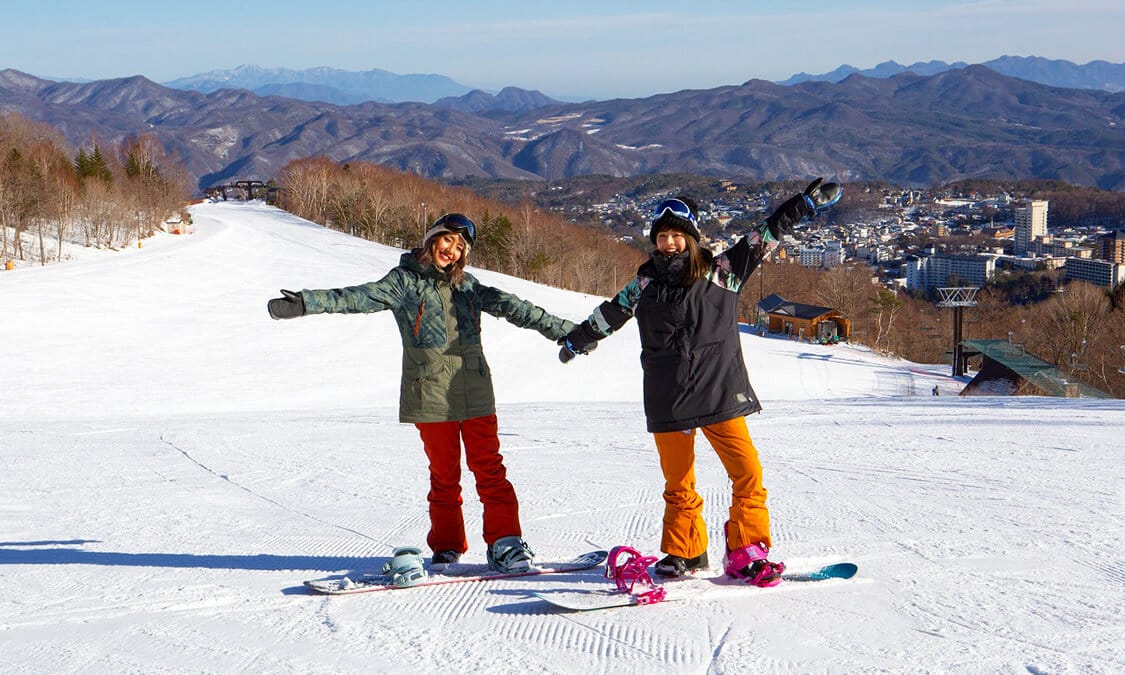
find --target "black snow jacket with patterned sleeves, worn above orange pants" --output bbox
[588,239,763,432]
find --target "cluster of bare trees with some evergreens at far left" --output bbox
[0,114,189,264]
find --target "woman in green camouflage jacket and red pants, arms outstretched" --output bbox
[269,214,574,572]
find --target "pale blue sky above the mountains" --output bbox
[0,0,1125,99]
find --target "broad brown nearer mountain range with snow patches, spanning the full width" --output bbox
[0,65,1125,190]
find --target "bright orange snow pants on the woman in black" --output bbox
[653,417,772,558]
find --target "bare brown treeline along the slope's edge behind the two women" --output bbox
[277,158,642,296]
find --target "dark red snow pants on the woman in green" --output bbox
[414,414,523,554]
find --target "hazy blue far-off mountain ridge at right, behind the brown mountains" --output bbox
[777,56,1125,91]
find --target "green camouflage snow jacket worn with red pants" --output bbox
[300,252,574,423]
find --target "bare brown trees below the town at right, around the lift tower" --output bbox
[741,260,1125,398]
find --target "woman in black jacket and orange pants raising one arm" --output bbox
[559,179,840,586]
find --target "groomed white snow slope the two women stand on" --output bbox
[0,204,1125,673]
